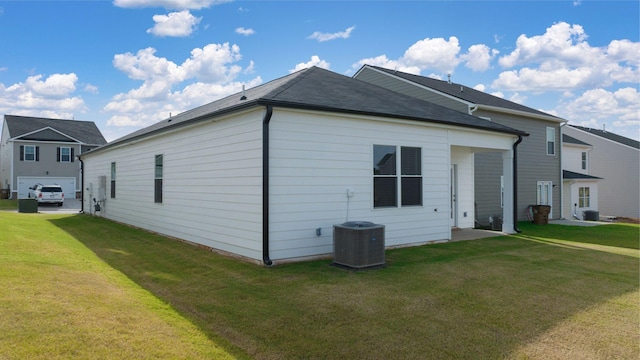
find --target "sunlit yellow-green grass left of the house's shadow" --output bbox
[0,212,246,359]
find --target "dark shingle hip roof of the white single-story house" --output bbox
[96,67,527,150]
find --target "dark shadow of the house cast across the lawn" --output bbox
[51,215,639,359]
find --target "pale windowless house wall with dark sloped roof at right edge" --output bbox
[563,125,640,219]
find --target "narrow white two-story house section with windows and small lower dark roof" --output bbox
[562,134,601,220]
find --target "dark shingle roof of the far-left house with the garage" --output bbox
[4,115,107,145]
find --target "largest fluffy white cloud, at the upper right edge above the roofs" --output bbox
[493,22,640,90]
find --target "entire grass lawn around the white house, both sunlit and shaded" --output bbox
[0,212,640,359]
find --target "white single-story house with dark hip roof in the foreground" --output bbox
[81,67,526,265]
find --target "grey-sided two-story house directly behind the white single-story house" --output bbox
[354,65,566,222]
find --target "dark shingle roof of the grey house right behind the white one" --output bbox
[367,65,564,121]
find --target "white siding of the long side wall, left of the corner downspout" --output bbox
[84,109,264,260]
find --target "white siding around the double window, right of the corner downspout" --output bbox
[270,110,450,259]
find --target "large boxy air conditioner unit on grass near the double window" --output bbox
[333,221,385,268]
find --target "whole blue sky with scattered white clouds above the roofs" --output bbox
[0,0,640,141]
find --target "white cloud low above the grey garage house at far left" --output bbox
[0,73,86,118]
